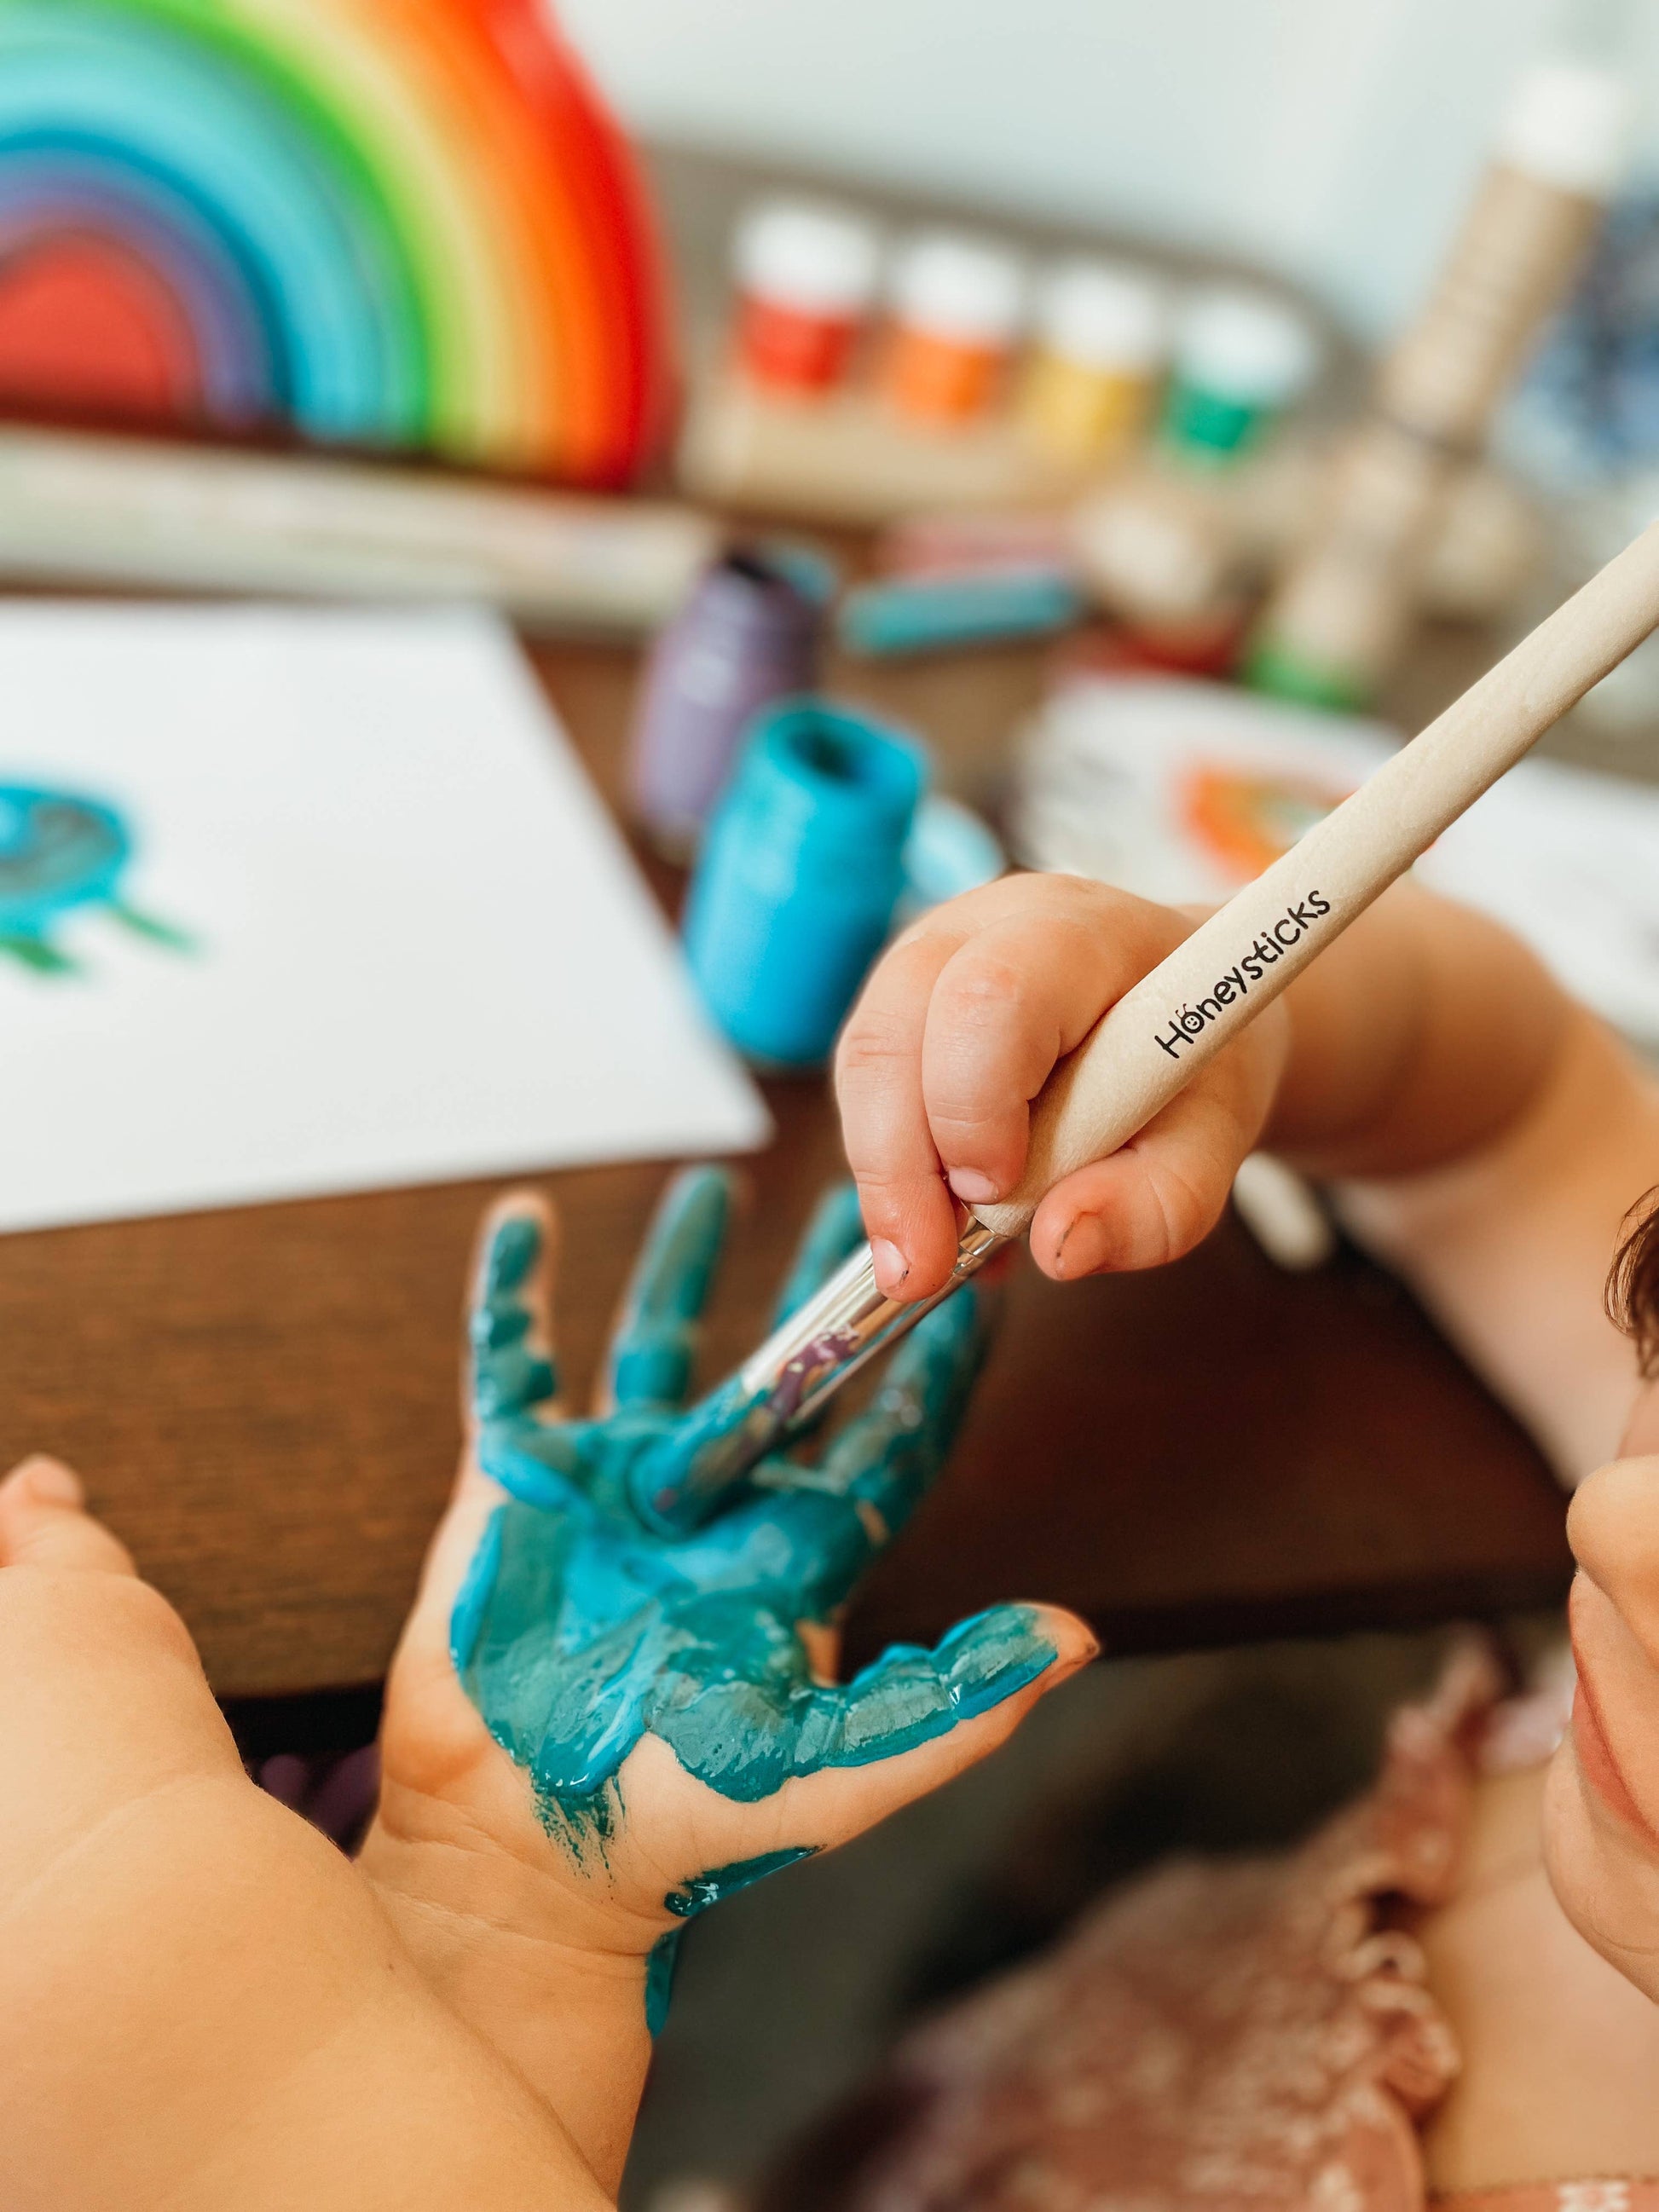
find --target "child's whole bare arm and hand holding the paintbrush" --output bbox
[836,876,1659,1477]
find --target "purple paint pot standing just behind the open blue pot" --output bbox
[630,546,834,860]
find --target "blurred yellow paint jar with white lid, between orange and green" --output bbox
[1020,261,1168,465]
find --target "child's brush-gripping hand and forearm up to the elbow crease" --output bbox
[836,876,1557,1298]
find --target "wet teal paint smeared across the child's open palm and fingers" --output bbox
[451,1170,1055,1856]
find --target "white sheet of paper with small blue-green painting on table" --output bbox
[0,602,770,1230]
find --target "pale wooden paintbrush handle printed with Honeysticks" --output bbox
[974,522,1659,1237]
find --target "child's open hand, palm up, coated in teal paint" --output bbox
[365,1170,1095,2134]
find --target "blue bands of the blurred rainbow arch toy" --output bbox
[0,0,427,445]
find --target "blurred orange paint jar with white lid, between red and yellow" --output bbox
[881,230,1026,427]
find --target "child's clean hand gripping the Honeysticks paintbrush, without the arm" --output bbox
[836,876,1287,1298]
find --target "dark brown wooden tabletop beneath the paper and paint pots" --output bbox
[0,623,1566,1745]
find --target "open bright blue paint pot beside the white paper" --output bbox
[684,699,927,1068]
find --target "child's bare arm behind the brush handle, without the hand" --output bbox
[1265,885,1659,1482]
